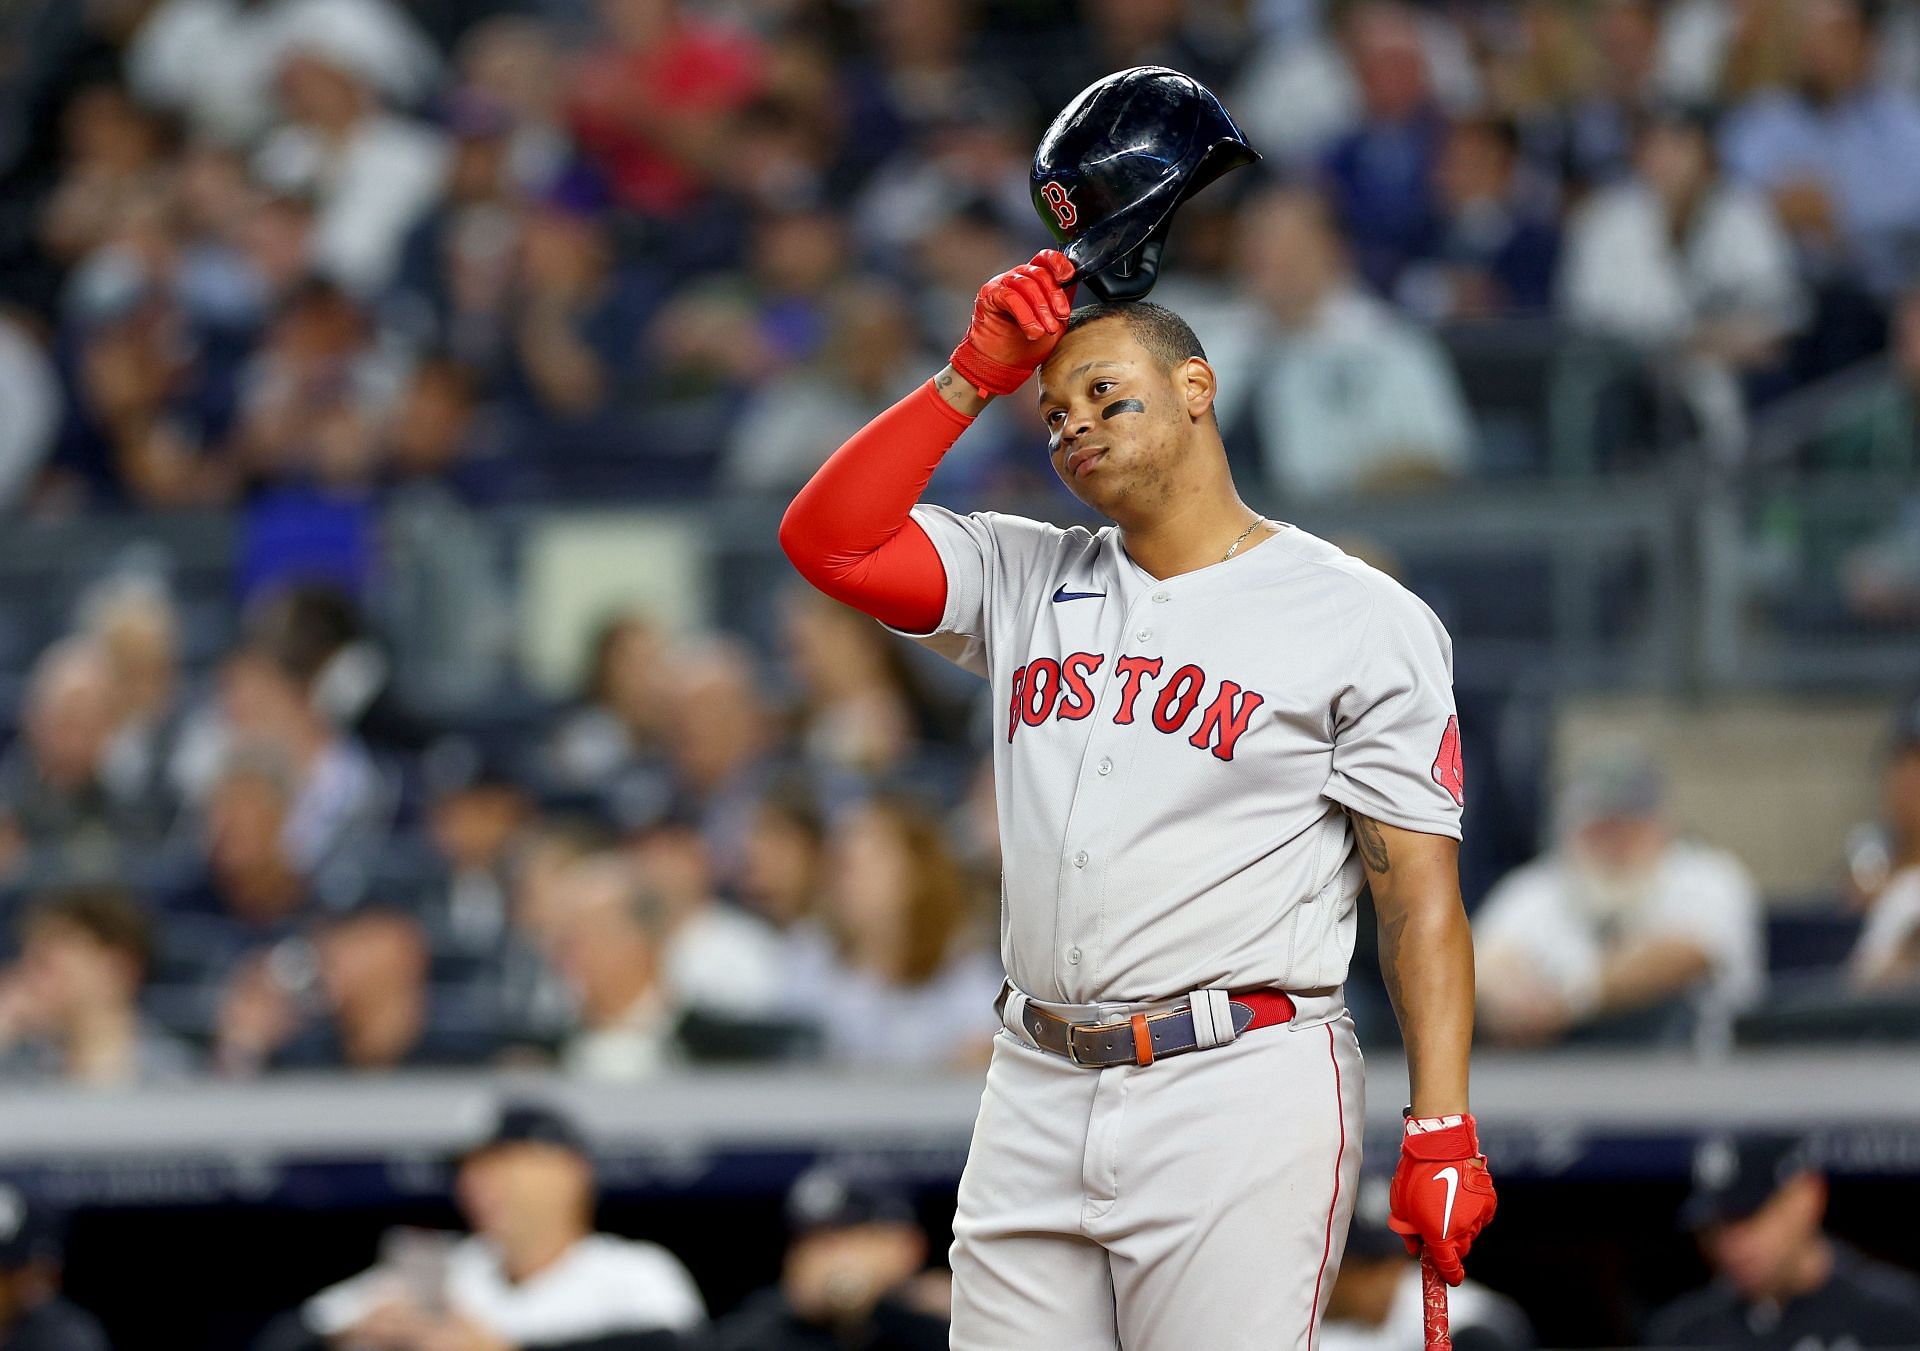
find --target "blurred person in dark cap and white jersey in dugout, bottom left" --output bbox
[270,1102,707,1351]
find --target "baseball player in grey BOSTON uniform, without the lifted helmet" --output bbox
[781,249,1494,1351]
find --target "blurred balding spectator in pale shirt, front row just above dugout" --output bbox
[547,854,680,1082]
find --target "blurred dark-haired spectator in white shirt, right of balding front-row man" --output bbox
[628,819,785,1019]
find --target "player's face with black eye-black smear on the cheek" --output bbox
[1039,319,1192,516]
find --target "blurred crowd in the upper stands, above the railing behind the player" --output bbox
[0,0,1920,521]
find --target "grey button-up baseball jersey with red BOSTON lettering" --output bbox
[890,505,1463,1004]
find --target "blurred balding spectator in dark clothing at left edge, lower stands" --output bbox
[0,637,167,871]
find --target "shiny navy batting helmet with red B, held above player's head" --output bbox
[1033,65,1260,299]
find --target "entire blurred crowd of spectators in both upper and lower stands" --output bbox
[0,0,1920,1082]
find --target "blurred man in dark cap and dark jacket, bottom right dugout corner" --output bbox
[1647,1136,1920,1351]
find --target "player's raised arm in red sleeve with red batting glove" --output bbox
[780,249,1073,633]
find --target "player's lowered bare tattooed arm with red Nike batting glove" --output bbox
[1350,812,1494,1286]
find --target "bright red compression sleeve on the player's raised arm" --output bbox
[780,380,973,633]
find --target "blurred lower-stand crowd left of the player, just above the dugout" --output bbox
[0,568,1000,1082]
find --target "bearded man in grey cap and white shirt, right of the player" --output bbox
[1473,745,1764,1044]
